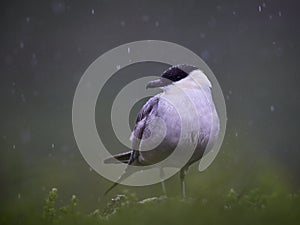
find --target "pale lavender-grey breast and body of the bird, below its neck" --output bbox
[133,84,219,167]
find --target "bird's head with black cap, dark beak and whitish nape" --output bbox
[146,64,211,89]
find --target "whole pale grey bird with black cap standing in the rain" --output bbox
[104,64,220,198]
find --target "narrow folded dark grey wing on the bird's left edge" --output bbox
[129,96,159,164]
